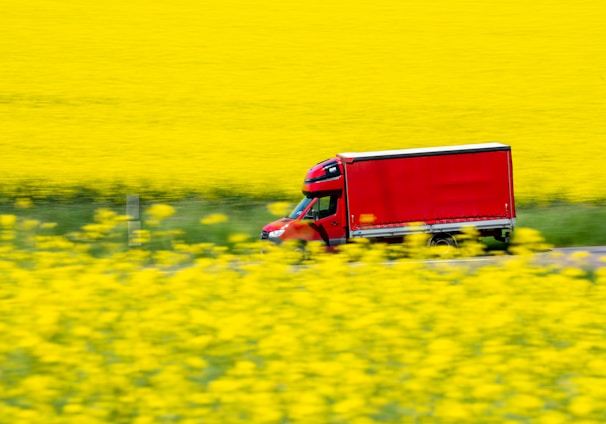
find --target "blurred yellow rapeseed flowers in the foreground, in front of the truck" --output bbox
[0,214,606,424]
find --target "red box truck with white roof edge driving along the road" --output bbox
[261,143,516,246]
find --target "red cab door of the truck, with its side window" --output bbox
[305,194,346,246]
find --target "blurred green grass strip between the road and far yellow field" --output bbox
[0,197,606,247]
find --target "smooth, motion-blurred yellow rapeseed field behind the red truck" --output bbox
[0,0,606,201]
